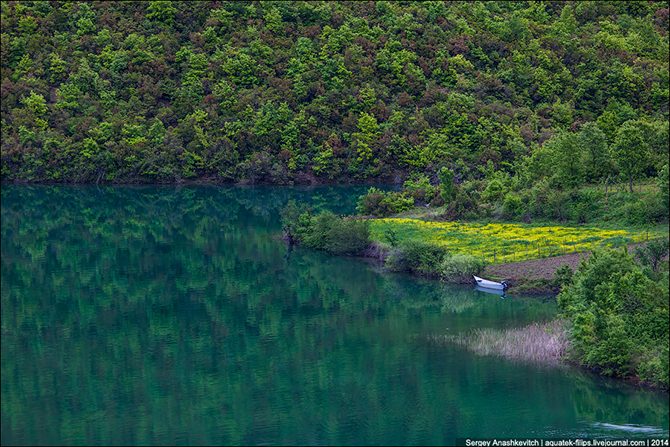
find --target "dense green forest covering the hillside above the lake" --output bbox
[1,1,669,186]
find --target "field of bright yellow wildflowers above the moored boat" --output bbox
[370,218,648,263]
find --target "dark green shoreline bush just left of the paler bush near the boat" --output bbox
[385,240,447,276]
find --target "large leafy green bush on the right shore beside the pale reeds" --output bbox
[558,250,670,387]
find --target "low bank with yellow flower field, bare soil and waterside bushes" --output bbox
[284,203,667,294]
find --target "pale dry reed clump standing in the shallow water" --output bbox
[432,320,569,364]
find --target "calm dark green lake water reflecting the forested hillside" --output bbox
[1,186,668,444]
